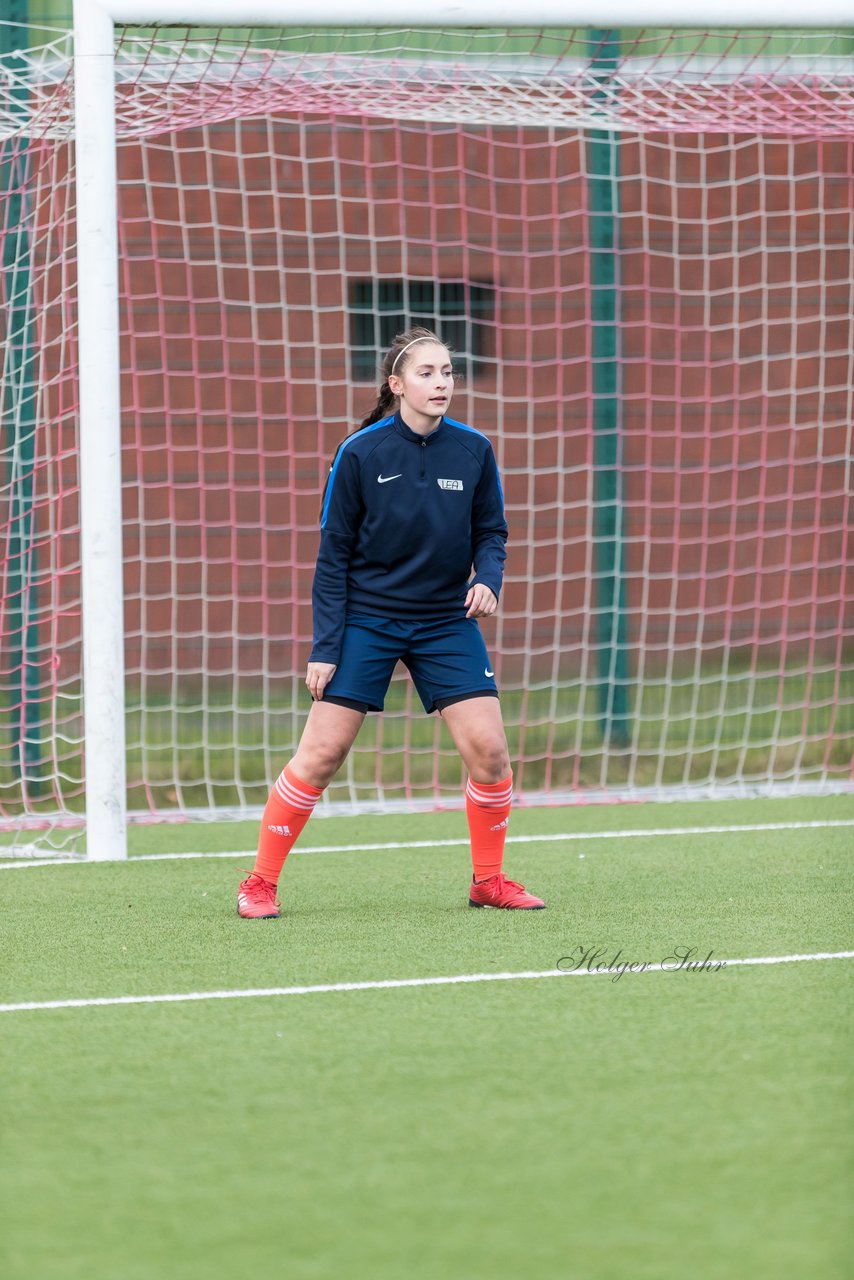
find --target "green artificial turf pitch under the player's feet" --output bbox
[0,797,854,1280]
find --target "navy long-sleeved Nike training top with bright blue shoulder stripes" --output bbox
[309,413,507,664]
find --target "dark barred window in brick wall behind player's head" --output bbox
[348,279,495,383]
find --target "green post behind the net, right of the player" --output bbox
[586,31,631,746]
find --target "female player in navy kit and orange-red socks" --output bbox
[237,329,545,919]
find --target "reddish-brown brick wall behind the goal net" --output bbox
[23,118,854,673]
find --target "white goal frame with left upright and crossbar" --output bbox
[61,0,853,859]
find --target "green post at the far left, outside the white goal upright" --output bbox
[0,0,42,795]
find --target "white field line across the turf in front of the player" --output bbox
[0,951,854,1014]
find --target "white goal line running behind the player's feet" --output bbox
[0,818,854,872]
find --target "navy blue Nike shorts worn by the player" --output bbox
[323,614,498,714]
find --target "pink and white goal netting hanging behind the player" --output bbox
[0,24,854,824]
